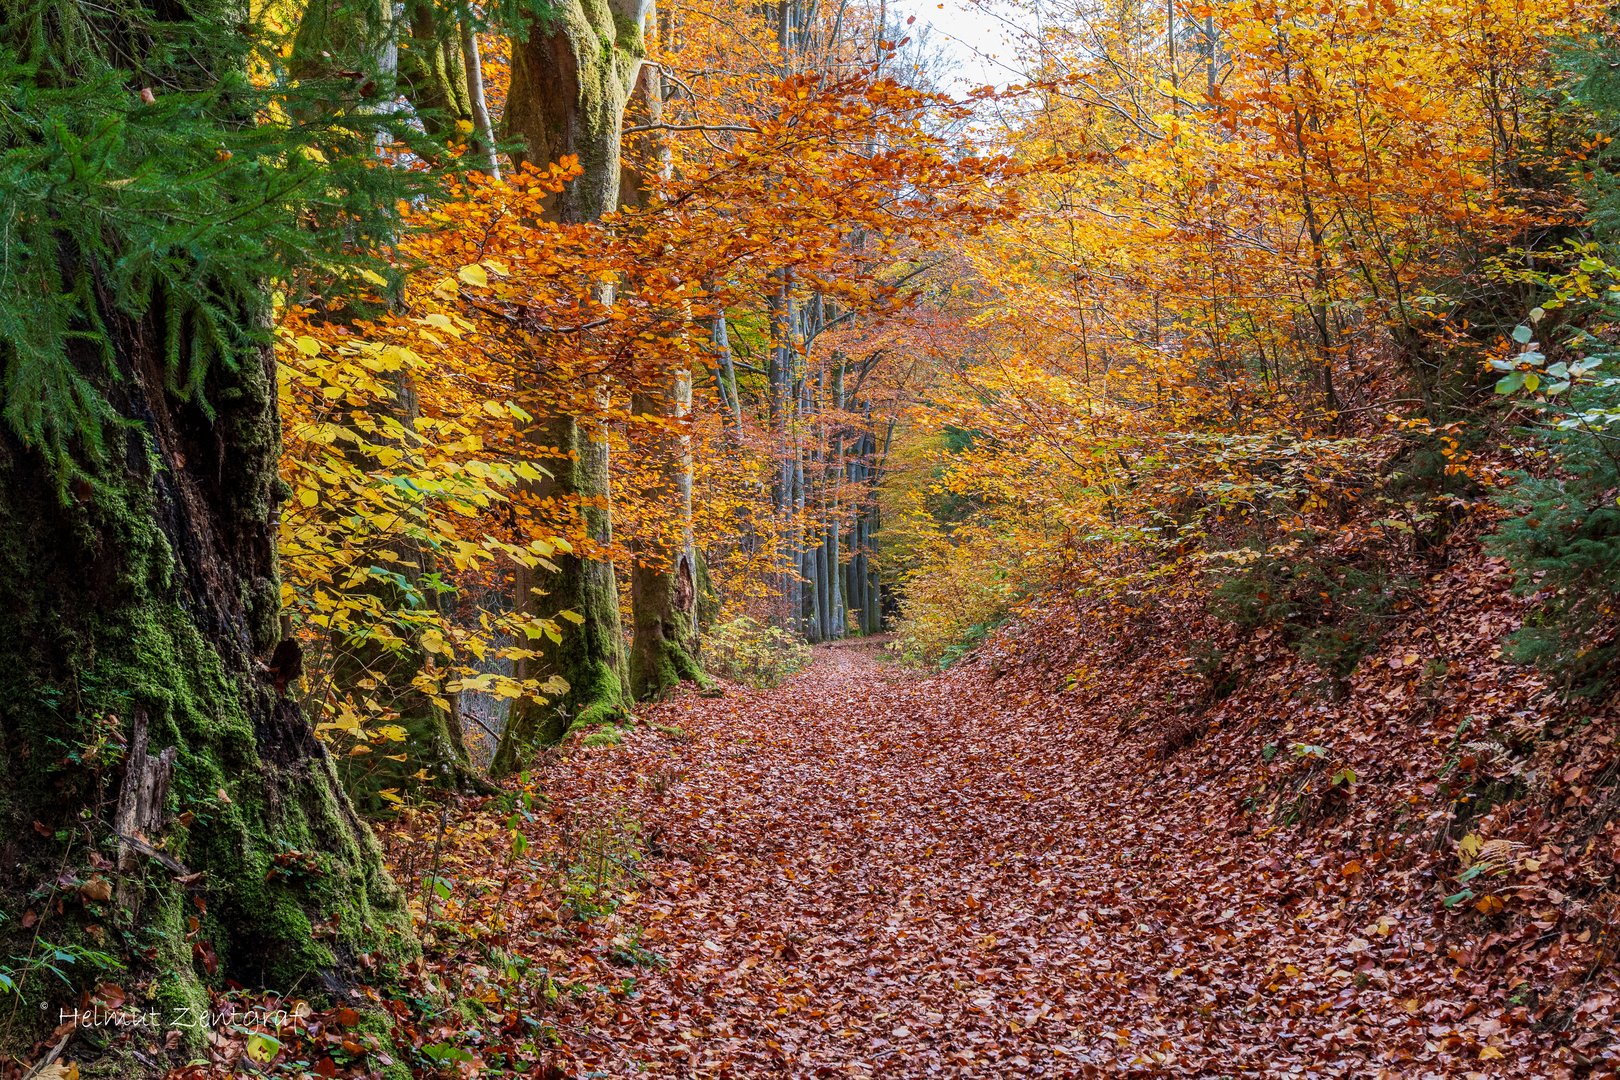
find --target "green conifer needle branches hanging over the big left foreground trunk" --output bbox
[0,0,434,491]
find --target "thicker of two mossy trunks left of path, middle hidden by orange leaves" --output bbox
[491,0,650,776]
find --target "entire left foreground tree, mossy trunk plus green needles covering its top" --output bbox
[0,0,416,1055]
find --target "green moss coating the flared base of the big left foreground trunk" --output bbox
[0,367,415,1062]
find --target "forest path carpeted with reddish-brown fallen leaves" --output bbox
[548,644,1516,1077]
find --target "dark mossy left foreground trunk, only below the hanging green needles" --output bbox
[0,318,415,1038]
